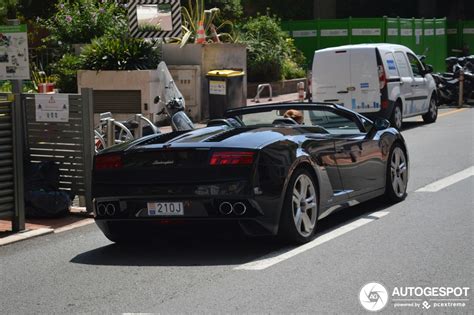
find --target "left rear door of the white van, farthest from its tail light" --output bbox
[312,48,351,108]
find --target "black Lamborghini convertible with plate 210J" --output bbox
[93,103,408,243]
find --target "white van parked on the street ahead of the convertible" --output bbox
[312,44,438,129]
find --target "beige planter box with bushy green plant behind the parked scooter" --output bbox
[77,34,161,120]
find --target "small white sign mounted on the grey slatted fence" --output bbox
[35,94,69,122]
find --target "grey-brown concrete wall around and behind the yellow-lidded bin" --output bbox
[163,44,247,120]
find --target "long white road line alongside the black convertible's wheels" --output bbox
[234,211,389,270]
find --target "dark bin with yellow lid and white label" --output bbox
[207,69,246,119]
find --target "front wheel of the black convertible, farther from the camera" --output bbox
[385,143,408,203]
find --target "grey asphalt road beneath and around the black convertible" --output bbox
[0,109,474,314]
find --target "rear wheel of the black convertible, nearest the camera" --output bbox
[278,168,319,244]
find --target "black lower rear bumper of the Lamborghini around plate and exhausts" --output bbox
[94,196,280,236]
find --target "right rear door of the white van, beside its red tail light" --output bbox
[350,47,381,113]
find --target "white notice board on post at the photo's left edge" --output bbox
[0,25,30,80]
